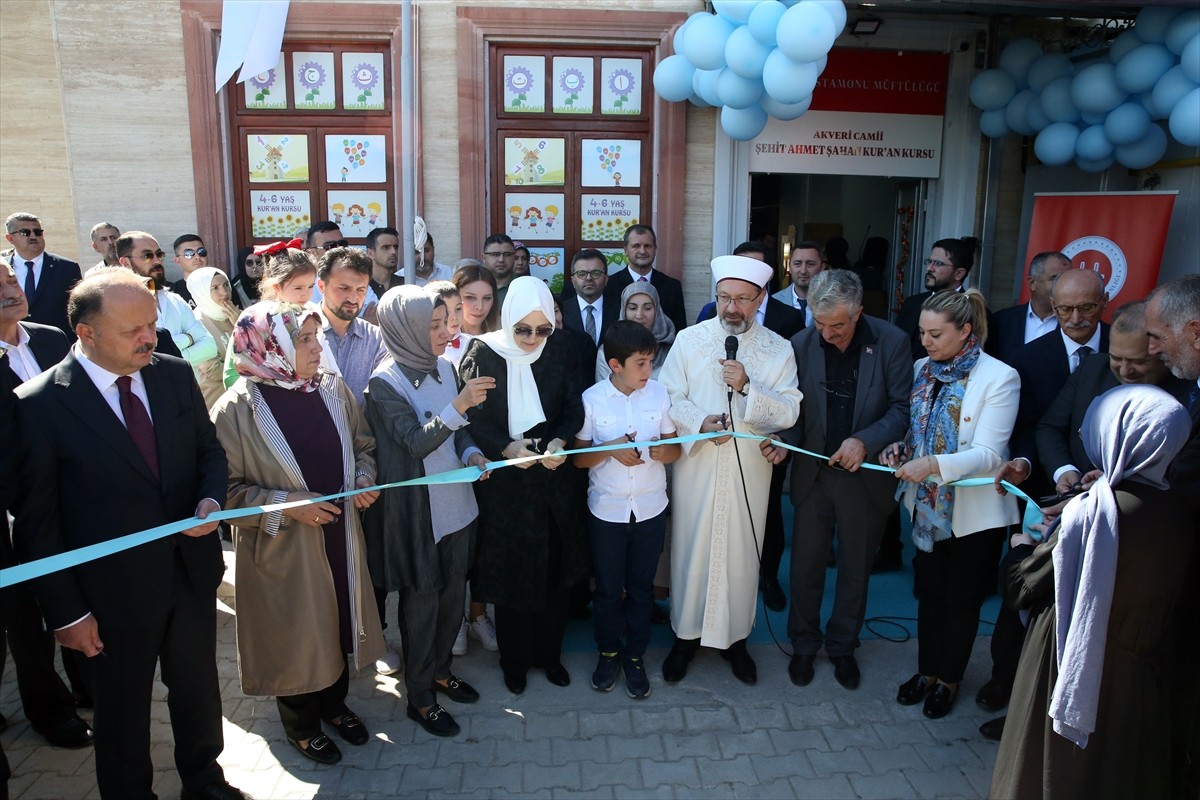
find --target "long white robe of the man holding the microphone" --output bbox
[659,319,803,649]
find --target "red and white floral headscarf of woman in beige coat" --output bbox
[233,300,322,392]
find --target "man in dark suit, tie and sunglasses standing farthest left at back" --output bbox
[5,211,80,341]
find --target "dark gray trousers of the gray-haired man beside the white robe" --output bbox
[787,465,895,656]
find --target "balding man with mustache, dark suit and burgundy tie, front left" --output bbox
[13,270,245,800]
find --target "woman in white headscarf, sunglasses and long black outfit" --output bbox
[458,276,588,693]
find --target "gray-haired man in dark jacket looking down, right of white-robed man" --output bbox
[763,270,912,688]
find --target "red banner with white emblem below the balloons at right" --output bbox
[1021,192,1177,319]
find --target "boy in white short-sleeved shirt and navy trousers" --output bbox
[575,320,683,699]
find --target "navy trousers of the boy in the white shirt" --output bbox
[588,511,667,658]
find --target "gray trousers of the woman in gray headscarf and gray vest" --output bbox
[397,522,475,709]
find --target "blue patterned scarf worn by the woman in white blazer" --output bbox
[908,333,982,553]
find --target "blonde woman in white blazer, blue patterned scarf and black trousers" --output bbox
[882,289,1021,720]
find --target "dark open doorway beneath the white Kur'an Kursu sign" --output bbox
[750,173,928,319]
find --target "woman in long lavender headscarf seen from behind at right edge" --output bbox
[988,385,1195,798]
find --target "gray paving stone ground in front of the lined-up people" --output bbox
[0,553,996,800]
